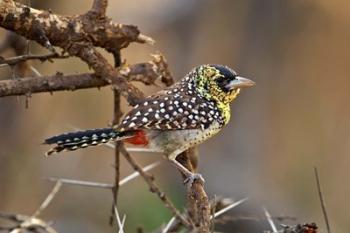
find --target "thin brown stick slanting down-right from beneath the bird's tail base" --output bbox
[120,143,193,229]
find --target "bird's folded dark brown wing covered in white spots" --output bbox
[117,93,222,131]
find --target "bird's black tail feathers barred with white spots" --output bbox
[44,128,132,156]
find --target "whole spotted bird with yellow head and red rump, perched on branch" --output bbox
[44,64,255,185]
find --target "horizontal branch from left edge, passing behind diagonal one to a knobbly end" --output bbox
[0,57,168,97]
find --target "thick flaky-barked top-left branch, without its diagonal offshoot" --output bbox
[0,0,152,52]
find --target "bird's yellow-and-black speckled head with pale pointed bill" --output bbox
[192,65,255,105]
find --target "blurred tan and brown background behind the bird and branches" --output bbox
[0,0,350,233]
